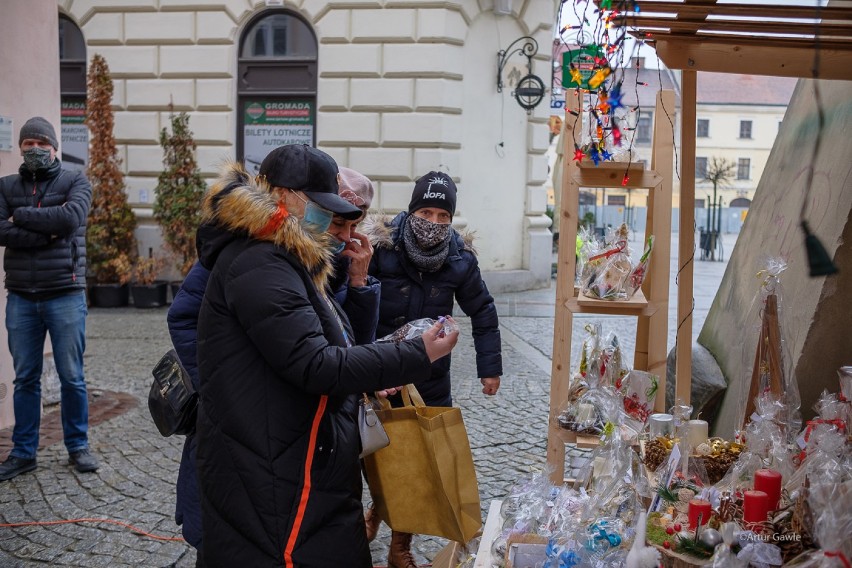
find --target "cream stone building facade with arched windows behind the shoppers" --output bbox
[57,0,555,290]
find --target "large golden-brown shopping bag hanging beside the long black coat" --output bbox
[364,385,482,543]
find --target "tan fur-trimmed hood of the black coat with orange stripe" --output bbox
[198,162,333,291]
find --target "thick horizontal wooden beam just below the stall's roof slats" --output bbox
[655,36,852,81]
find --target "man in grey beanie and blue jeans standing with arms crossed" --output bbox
[0,116,98,481]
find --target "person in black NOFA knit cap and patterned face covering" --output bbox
[366,171,503,568]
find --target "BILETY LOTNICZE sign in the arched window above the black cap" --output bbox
[243,99,314,174]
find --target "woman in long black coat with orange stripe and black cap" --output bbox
[197,145,458,568]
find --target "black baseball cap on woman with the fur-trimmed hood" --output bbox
[259,144,362,220]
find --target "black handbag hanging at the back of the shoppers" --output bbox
[148,349,198,436]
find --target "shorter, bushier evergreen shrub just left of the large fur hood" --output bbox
[154,112,207,293]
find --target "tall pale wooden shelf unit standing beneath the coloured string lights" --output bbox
[547,87,675,483]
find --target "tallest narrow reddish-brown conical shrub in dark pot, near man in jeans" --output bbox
[86,54,138,306]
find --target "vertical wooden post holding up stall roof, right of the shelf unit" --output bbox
[675,70,698,404]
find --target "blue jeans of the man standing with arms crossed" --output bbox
[6,290,89,459]
